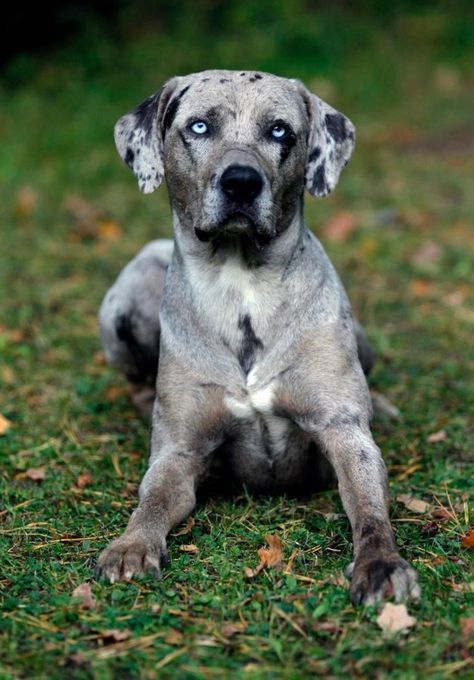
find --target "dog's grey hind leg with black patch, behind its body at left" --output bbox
[99,239,173,417]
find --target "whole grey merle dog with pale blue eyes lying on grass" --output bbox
[98,71,419,604]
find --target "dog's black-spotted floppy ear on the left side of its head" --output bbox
[114,78,178,194]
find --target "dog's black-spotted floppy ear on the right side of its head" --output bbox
[301,85,355,196]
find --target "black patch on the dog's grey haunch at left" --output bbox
[115,314,159,384]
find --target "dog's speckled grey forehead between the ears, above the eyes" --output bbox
[175,70,303,116]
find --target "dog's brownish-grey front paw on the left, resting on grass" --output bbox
[96,531,169,583]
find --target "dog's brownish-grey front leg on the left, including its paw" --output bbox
[97,380,228,582]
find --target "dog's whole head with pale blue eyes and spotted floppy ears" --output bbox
[115,71,355,242]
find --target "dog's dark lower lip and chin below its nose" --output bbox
[194,210,273,249]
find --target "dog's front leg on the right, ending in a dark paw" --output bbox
[314,420,420,604]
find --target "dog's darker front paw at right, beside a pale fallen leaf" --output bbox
[346,554,421,605]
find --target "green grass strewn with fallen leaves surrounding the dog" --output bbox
[0,3,474,679]
